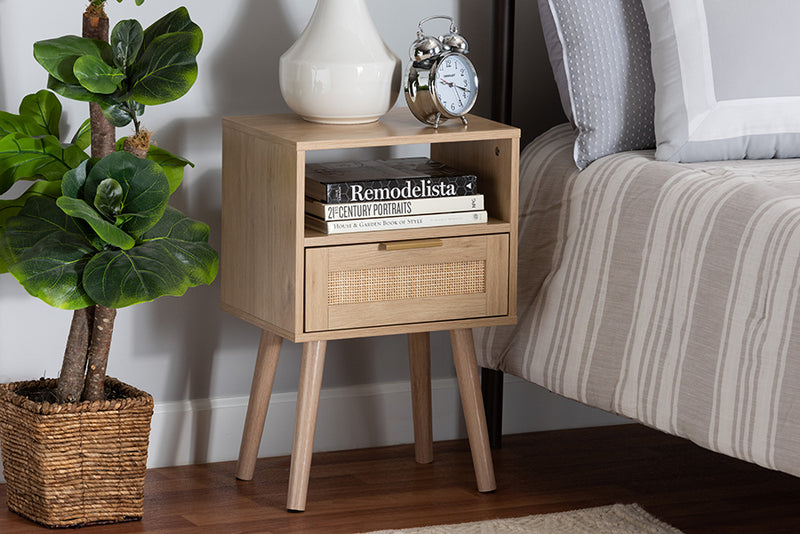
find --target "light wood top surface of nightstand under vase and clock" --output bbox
[222,108,520,150]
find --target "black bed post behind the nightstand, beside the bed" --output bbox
[481,0,515,449]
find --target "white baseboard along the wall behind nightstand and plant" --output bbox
[0,375,628,486]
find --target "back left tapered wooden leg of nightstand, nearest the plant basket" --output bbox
[236,330,283,480]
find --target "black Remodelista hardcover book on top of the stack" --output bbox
[306,158,478,204]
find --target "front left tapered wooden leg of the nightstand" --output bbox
[286,341,326,512]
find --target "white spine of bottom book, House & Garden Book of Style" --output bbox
[306,210,488,234]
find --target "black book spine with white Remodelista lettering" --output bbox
[306,174,478,204]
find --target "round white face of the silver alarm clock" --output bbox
[435,54,478,117]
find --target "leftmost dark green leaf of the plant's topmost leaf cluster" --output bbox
[33,35,112,85]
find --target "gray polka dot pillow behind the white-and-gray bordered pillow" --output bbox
[539,0,656,169]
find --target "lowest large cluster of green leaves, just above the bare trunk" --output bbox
[0,152,217,309]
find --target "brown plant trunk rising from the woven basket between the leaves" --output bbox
[58,4,116,402]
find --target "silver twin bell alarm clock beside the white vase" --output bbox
[404,15,478,128]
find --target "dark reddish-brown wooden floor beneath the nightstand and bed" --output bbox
[0,425,800,534]
